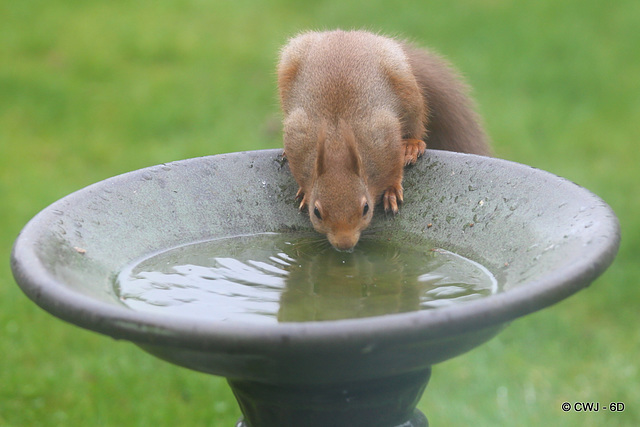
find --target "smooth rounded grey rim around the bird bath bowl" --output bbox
[11,150,620,349]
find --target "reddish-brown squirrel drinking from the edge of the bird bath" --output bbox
[277,30,490,251]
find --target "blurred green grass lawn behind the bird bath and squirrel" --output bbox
[0,0,640,427]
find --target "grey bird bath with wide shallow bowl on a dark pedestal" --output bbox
[11,150,620,427]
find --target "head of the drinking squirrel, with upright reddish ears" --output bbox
[308,121,375,251]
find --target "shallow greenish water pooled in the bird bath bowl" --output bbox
[114,233,498,323]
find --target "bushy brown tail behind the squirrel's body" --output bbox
[403,44,491,156]
